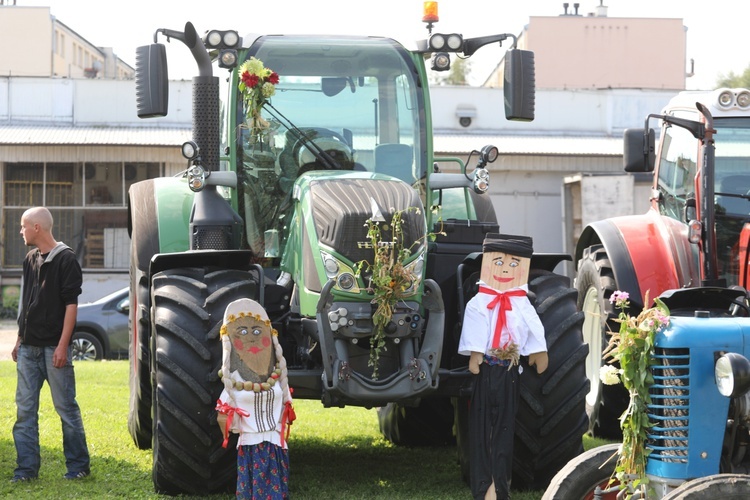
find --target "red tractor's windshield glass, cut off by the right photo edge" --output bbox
[714,117,750,285]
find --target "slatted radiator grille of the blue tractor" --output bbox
[648,348,690,463]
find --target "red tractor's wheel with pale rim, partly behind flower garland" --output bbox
[576,245,633,441]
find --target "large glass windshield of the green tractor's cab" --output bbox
[236,36,426,257]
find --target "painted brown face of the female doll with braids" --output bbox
[227,316,274,376]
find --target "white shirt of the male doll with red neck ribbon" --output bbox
[458,282,547,356]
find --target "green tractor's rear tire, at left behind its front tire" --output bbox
[128,180,159,450]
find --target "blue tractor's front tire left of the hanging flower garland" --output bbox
[542,444,620,500]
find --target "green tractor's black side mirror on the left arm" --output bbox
[135,43,169,118]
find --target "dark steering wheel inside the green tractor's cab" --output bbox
[292,127,354,175]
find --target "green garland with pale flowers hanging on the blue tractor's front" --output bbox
[601,291,669,498]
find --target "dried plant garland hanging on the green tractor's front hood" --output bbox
[356,207,443,380]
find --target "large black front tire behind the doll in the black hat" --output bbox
[455,269,589,489]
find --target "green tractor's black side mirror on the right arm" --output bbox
[503,49,536,122]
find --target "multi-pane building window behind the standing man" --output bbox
[1,162,163,270]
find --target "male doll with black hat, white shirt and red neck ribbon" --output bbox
[458,233,548,499]
